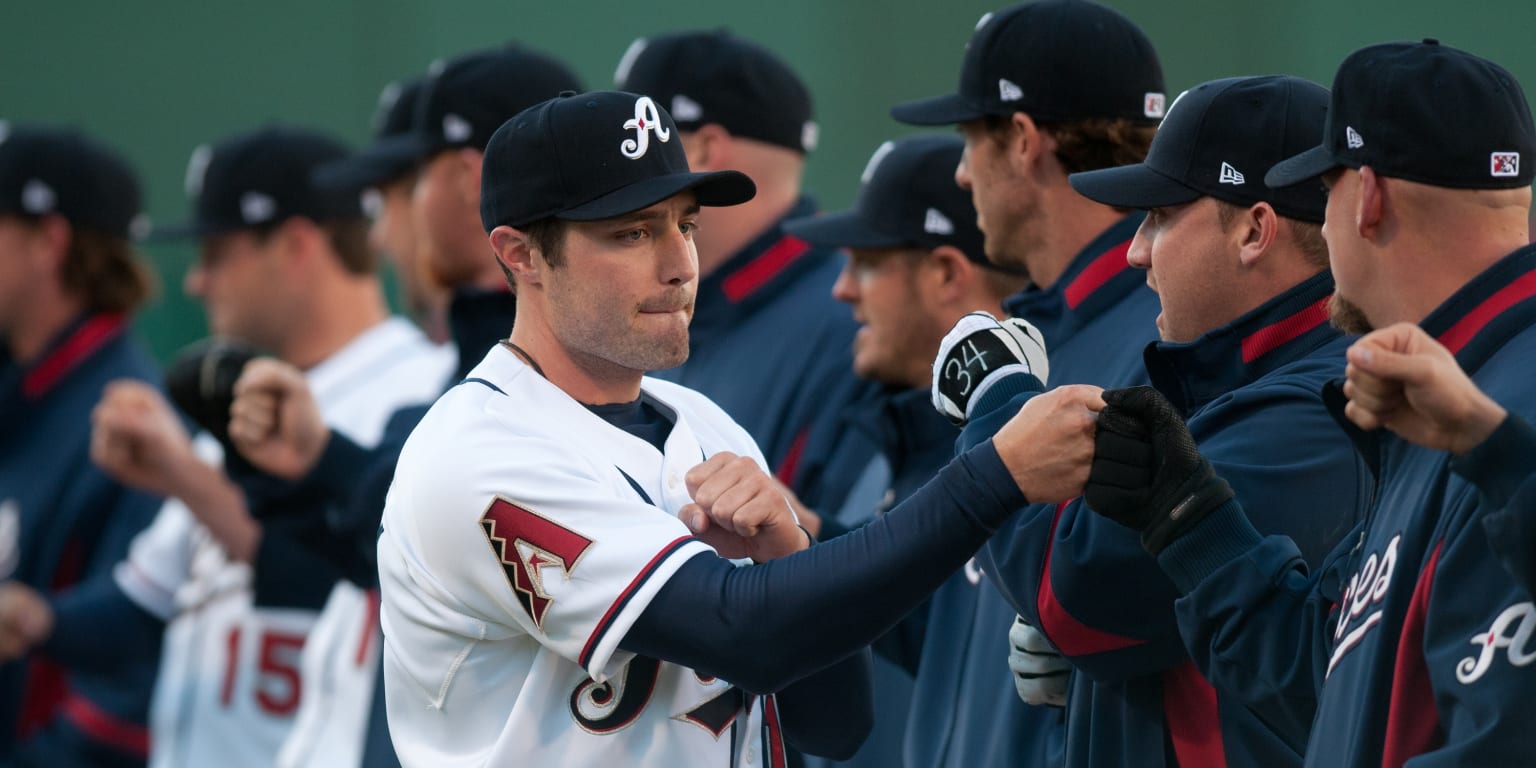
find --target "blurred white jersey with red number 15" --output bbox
[115,318,453,768]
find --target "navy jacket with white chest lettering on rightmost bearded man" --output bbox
[1160,247,1536,766]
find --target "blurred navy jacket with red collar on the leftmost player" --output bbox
[0,315,160,765]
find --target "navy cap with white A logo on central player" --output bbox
[481,91,757,232]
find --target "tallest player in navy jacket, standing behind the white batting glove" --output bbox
[891,0,1164,766]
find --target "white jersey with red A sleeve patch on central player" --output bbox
[379,347,782,768]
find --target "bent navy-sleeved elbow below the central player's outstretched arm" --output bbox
[776,650,874,760]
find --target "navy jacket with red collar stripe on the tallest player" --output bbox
[906,214,1158,768]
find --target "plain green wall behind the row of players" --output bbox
[0,0,1536,359]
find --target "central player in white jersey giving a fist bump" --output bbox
[379,92,1097,766]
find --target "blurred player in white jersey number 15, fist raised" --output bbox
[68,127,450,765]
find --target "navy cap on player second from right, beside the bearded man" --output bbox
[1068,75,1329,223]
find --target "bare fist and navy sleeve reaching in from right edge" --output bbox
[1344,323,1536,594]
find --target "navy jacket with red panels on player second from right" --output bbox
[970,272,1370,768]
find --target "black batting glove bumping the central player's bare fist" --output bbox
[1083,387,1232,556]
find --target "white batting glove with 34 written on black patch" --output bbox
[932,312,1051,425]
